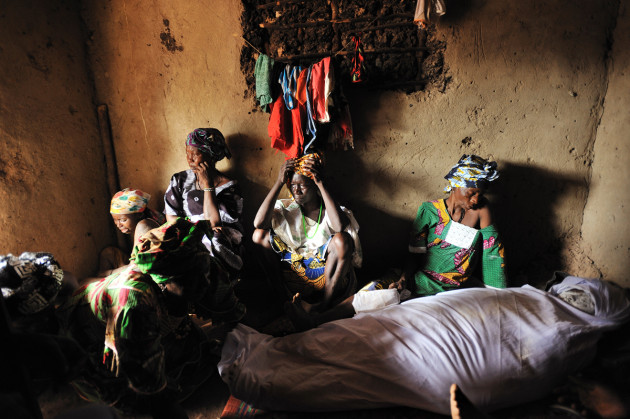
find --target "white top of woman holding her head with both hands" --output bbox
[271,199,363,268]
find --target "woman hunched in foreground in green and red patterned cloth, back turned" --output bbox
[57,218,245,417]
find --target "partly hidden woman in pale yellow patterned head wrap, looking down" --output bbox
[97,188,165,278]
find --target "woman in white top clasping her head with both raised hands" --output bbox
[253,153,362,320]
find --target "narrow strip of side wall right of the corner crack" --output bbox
[582,1,630,285]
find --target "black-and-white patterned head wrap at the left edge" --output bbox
[0,252,63,315]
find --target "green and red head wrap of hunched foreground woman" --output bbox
[130,218,210,284]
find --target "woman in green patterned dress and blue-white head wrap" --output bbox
[392,154,506,296]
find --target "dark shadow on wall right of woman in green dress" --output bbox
[489,163,587,286]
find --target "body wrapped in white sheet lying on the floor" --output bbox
[219,277,630,414]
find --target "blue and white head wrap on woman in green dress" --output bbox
[444,154,499,192]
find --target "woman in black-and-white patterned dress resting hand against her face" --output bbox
[164,128,244,279]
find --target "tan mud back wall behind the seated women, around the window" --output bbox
[71,0,630,285]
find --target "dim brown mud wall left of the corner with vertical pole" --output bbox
[0,0,113,276]
